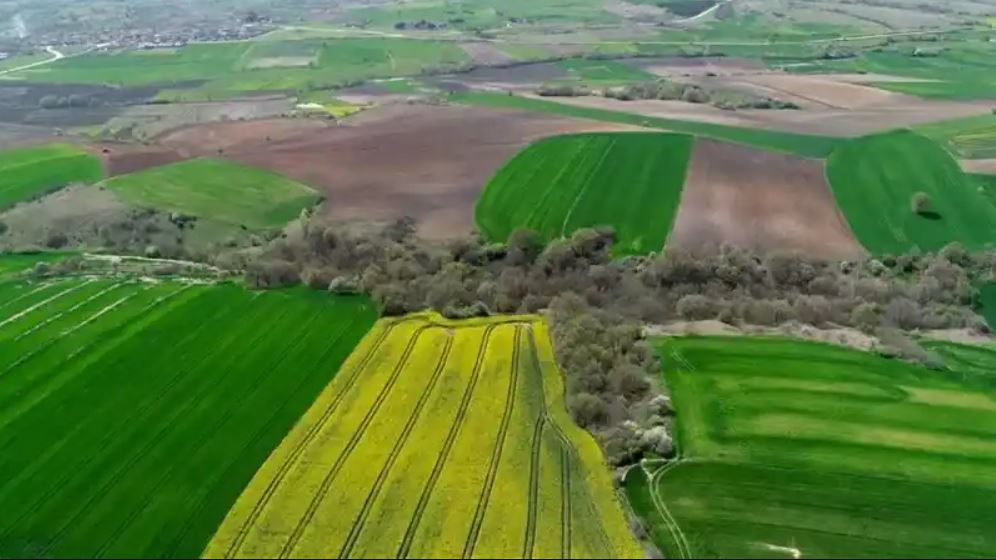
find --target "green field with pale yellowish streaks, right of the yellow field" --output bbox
[626,338,996,558]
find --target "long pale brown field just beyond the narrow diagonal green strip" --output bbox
[544,95,992,137]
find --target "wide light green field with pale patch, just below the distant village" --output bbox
[12,38,470,101]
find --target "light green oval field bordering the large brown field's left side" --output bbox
[104,158,320,229]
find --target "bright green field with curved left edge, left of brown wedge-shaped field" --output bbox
[475,133,692,254]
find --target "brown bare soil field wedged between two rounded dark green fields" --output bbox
[668,139,864,259]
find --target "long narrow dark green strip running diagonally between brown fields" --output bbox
[451,93,844,158]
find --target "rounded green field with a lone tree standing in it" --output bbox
[827,131,996,254]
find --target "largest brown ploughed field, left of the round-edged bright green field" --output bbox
[161,104,634,238]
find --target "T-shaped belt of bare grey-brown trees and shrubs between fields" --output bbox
[235,215,996,464]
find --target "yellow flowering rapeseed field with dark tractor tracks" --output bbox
[204,314,642,558]
